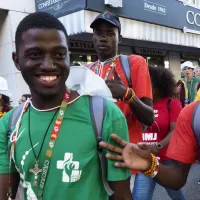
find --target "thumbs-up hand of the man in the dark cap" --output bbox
[106,67,127,100]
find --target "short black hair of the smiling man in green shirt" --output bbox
[15,12,68,52]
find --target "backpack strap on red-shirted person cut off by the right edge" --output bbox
[192,102,200,149]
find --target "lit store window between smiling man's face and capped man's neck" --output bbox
[70,53,98,66]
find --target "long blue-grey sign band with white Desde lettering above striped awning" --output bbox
[35,0,200,34]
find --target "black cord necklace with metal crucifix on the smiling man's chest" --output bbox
[28,107,58,186]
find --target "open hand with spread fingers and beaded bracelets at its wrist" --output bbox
[99,134,151,171]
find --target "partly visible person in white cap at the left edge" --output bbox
[0,77,12,118]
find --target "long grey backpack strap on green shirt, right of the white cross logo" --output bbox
[90,96,114,196]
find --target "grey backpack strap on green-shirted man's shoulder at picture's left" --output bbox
[8,103,24,137]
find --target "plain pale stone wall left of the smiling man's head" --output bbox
[0,0,35,105]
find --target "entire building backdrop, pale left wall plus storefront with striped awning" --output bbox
[0,0,200,105]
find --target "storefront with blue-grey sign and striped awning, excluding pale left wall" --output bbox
[36,0,200,79]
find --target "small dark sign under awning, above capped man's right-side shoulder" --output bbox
[134,47,167,56]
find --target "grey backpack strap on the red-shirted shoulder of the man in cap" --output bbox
[119,55,132,88]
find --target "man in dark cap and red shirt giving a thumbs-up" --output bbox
[88,11,154,189]
